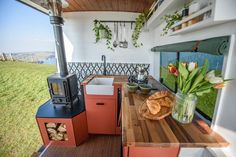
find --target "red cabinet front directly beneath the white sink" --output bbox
[83,82,121,135]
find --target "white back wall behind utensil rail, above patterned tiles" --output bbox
[63,12,153,73]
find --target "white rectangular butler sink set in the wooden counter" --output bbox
[85,78,114,95]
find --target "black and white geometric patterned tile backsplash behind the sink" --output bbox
[68,62,150,94]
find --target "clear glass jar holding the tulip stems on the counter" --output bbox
[172,91,197,124]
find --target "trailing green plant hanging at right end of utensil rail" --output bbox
[132,12,148,47]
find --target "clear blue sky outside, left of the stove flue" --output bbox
[0,0,54,53]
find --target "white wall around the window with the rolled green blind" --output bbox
[152,21,236,157]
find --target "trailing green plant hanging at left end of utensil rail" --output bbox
[93,20,114,51]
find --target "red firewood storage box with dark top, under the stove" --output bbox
[36,100,88,146]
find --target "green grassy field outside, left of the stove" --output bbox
[0,62,56,157]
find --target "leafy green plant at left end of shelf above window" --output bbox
[162,11,182,35]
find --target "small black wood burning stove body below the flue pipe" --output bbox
[47,74,78,108]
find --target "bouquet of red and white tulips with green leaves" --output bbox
[168,60,226,96]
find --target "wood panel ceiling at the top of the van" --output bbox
[64,0,154,13]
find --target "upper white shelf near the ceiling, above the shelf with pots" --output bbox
[147,0,186,29]
